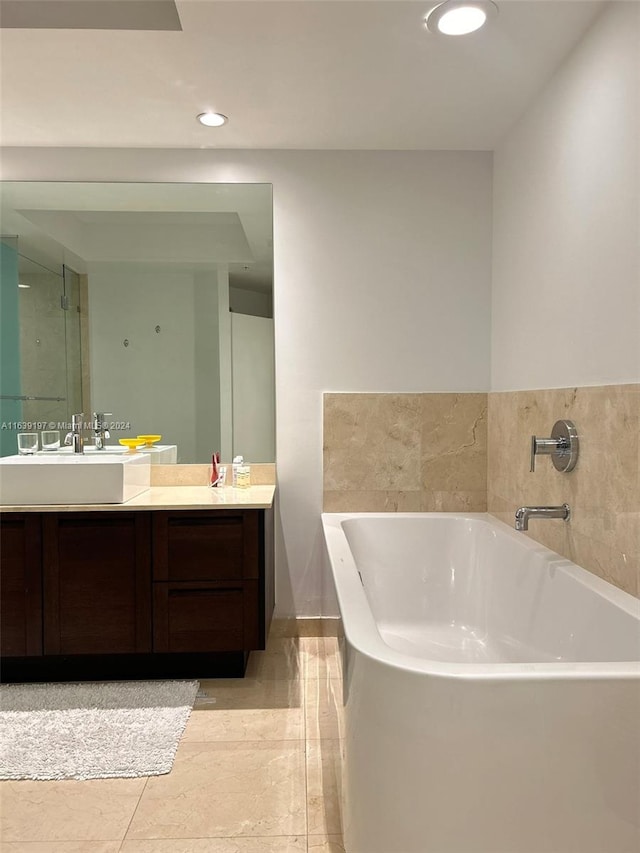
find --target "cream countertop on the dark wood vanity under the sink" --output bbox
[0,485,276,512]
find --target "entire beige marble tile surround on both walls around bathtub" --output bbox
[323,384,640,596]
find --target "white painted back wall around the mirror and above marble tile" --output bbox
[2,148,492,615]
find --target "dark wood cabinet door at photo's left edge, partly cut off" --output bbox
[0,513,42,657]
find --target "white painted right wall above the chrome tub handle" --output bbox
[491,2,640,390]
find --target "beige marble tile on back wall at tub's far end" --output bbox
[323,394,487,512]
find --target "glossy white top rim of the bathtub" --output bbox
[321,512,640,686]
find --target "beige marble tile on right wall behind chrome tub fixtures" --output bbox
[487,385,640,596]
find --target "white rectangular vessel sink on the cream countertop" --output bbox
[0,453,151,506]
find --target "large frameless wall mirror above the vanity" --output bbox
[0,181,275,463]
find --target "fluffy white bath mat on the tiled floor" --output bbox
[0,681,198,779]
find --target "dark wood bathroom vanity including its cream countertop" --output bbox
[0,486,275,681]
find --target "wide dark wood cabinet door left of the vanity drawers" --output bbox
[43,510,151,655]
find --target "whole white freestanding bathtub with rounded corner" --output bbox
[322,513,640,853]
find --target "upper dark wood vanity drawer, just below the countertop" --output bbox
[153,510,259,581]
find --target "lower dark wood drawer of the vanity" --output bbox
[153,581,257,652]
